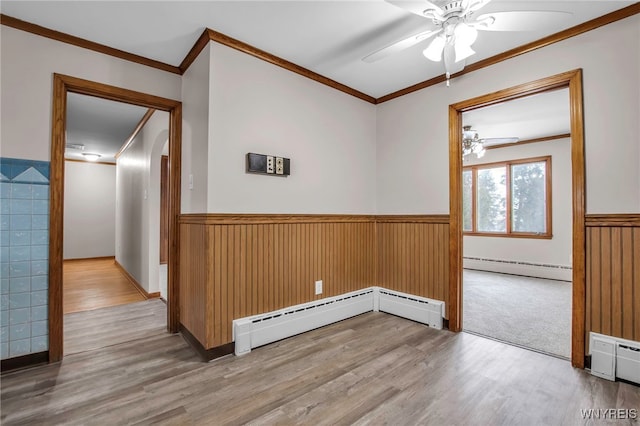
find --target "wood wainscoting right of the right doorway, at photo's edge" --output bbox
[585,214,640,350]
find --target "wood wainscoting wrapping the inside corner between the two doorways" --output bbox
[180,214,449,349]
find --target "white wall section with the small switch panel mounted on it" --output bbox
[202,43,376,214]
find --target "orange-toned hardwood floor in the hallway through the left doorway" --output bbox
[63,258,146,314]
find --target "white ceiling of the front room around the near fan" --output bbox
[0,0,635,98]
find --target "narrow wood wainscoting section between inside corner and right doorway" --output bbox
[376,215,449,318]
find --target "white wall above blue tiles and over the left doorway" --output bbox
[0,25,181,161]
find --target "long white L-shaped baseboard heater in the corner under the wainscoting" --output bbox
[233,287,444,355]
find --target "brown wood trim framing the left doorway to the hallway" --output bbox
[49,74,182,362]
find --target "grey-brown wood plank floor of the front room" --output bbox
[1,300,640,425]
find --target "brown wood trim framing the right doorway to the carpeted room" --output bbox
[449,69,586,368]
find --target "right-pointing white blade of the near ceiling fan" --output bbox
[469,10,572,31]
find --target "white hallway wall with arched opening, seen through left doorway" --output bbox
[116,111,169,293]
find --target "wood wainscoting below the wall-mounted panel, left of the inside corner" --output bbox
[180,214,376,349]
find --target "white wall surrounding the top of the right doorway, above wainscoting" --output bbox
[376,15,640,214]
